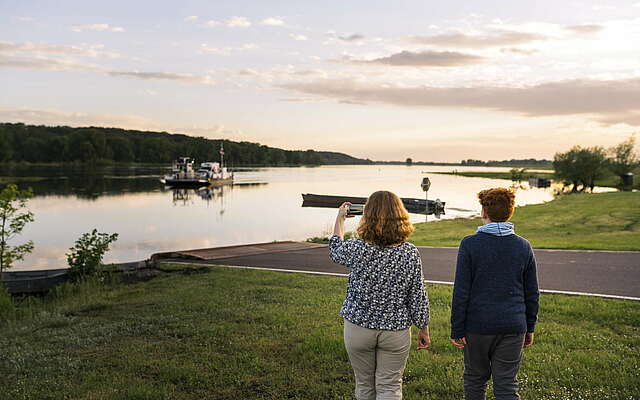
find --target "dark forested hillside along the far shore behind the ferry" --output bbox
[0,123,372,167]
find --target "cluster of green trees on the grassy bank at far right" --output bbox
[553,135,640,192]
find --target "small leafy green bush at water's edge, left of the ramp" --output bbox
[67,229,118,282]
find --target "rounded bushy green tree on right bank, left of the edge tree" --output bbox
[553,146,607,192]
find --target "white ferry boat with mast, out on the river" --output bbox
[160,147,233,187]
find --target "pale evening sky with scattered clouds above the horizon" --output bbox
[0,0,640,162]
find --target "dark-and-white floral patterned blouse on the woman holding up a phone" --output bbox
[329,235,429,331]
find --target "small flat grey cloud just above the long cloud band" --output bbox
[345,50,484,67]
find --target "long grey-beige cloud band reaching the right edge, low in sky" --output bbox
[279,78,640,124]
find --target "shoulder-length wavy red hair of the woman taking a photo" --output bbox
[357,190,415,246]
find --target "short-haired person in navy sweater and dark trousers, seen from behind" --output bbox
[451,188,540,400]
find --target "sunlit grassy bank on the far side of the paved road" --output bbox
[409,192,640,250]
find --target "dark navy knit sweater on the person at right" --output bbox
[451,232,540,339]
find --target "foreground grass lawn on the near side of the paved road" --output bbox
[0,265,640,400]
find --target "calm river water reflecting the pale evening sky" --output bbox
[0,166,592,269]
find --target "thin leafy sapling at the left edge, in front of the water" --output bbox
[0,184,33,273]
